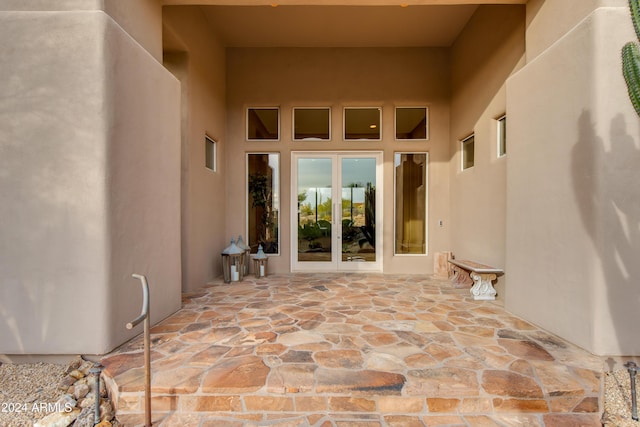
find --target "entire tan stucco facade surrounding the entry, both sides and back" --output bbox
[0,0,640,355]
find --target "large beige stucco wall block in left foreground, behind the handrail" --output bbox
[0,11,180,354]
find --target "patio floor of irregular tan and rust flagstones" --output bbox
[102,273,604,427]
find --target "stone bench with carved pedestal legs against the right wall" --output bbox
[448,259,504,300]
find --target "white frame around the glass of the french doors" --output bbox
[289,150,384,272]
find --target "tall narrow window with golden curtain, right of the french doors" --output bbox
[394,153,427,255]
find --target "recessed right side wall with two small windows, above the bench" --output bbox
[449,6,525,299]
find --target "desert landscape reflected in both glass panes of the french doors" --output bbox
[298,158,376,261]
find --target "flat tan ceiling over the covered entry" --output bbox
[163,0,526,48]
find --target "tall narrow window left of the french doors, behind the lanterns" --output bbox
[247,153,280,254]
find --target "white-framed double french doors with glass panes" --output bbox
[291,152,382,271]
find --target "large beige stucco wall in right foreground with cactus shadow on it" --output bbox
[506,2,640,355]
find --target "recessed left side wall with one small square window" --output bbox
[163,7,229,291]
